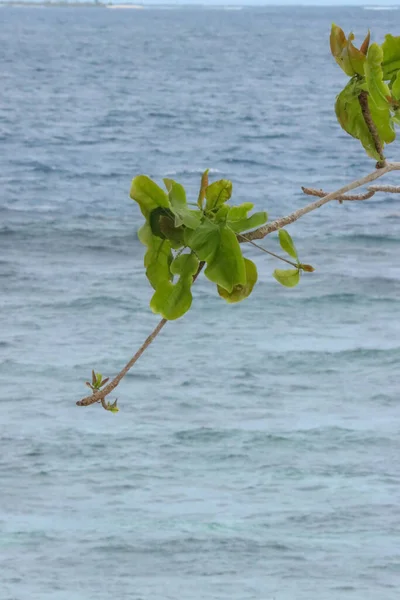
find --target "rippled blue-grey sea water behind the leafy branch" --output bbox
[0,8,400,600]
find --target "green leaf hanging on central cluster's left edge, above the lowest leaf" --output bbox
[138,223,173,289]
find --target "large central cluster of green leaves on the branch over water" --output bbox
[130,171,268,320]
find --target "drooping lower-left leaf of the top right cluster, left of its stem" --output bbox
[335,78,383,160]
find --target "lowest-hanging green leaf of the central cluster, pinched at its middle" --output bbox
[150,253,199,321]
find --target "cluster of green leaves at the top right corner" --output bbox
[330,24,400,161]
